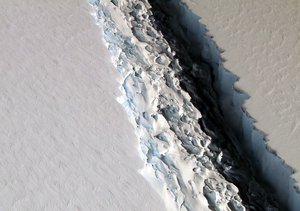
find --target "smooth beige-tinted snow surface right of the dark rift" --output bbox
[186,0,300,180]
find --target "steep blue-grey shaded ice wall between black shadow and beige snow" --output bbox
[154,0,300,210]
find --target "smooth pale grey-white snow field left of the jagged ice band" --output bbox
[0,0,165,211]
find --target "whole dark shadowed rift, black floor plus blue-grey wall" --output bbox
[149,0,300,210]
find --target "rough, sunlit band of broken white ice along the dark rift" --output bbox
[90,0,245,210]
